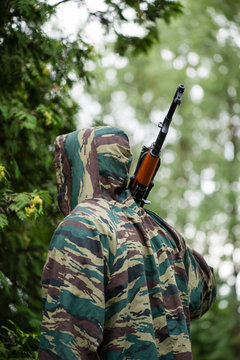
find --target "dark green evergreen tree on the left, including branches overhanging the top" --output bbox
[0,0,181,359]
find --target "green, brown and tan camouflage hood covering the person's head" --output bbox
[54,126,132,216]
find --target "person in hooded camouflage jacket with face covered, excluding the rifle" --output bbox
[39,127,215,360]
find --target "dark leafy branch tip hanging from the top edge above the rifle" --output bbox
[86,0,182,55]
